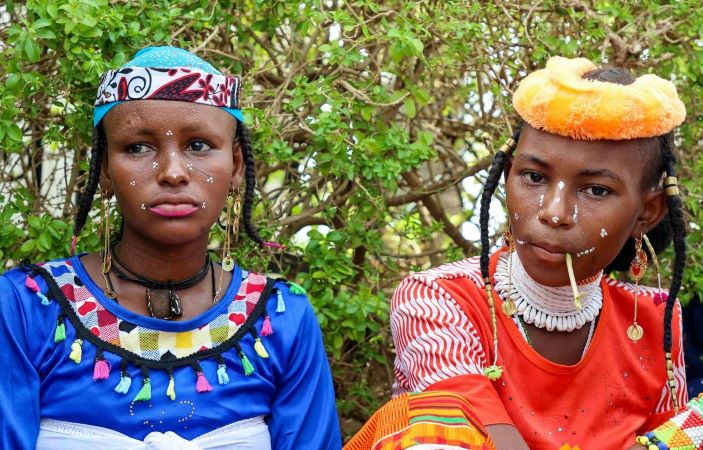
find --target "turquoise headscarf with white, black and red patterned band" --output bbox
[93,47,244,126]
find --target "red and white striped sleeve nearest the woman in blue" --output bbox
[391,274,487,395]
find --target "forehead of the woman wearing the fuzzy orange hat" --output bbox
[514,124,651,180]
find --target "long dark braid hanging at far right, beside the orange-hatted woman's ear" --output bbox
[659,133,686,411]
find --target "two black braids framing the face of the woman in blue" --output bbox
[73,121,264,245]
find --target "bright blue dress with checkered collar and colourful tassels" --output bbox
[0,256,341,450]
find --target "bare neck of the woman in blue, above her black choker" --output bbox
[113,226,208,282]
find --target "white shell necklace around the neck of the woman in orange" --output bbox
[494,252,603,332]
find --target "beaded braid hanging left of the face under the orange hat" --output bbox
[479,124,521,380]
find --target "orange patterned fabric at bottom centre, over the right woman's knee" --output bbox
[344,392,495,450]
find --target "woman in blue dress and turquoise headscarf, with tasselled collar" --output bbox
[0,47,341,449]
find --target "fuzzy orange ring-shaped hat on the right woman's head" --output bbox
[513,56,686,140]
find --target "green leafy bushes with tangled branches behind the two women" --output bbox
[0,0,703,440]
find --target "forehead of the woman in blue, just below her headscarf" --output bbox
[103,100,235,135]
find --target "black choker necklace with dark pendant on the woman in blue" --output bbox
[107,249,215,320]
